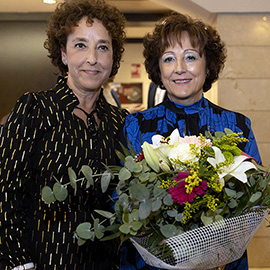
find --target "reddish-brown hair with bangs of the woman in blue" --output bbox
[143,13,227,92]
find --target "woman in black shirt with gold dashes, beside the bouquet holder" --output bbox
[0,0,127,270]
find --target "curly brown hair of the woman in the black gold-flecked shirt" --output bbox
[44,0,126,77]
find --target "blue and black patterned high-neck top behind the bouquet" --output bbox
[120,97,261,270]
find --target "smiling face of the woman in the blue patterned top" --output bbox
[159,32,206,105]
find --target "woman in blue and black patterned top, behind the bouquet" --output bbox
[120,13,261,270]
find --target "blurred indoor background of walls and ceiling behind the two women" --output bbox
[0,0,270,270]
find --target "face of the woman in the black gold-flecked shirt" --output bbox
[62,17,113,93]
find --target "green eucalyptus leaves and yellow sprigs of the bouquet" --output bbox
[42,129,270,260]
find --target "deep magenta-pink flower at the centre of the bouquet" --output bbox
[168,172,207,205]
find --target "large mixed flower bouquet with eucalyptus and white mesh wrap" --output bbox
[42,129,270,269]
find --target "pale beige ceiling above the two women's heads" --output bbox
[0,0,270,38]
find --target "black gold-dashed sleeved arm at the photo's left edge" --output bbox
[0,94,43,269]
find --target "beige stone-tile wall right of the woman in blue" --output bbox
[217,14,270,268]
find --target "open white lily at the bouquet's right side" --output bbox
[207,146,256,183]
